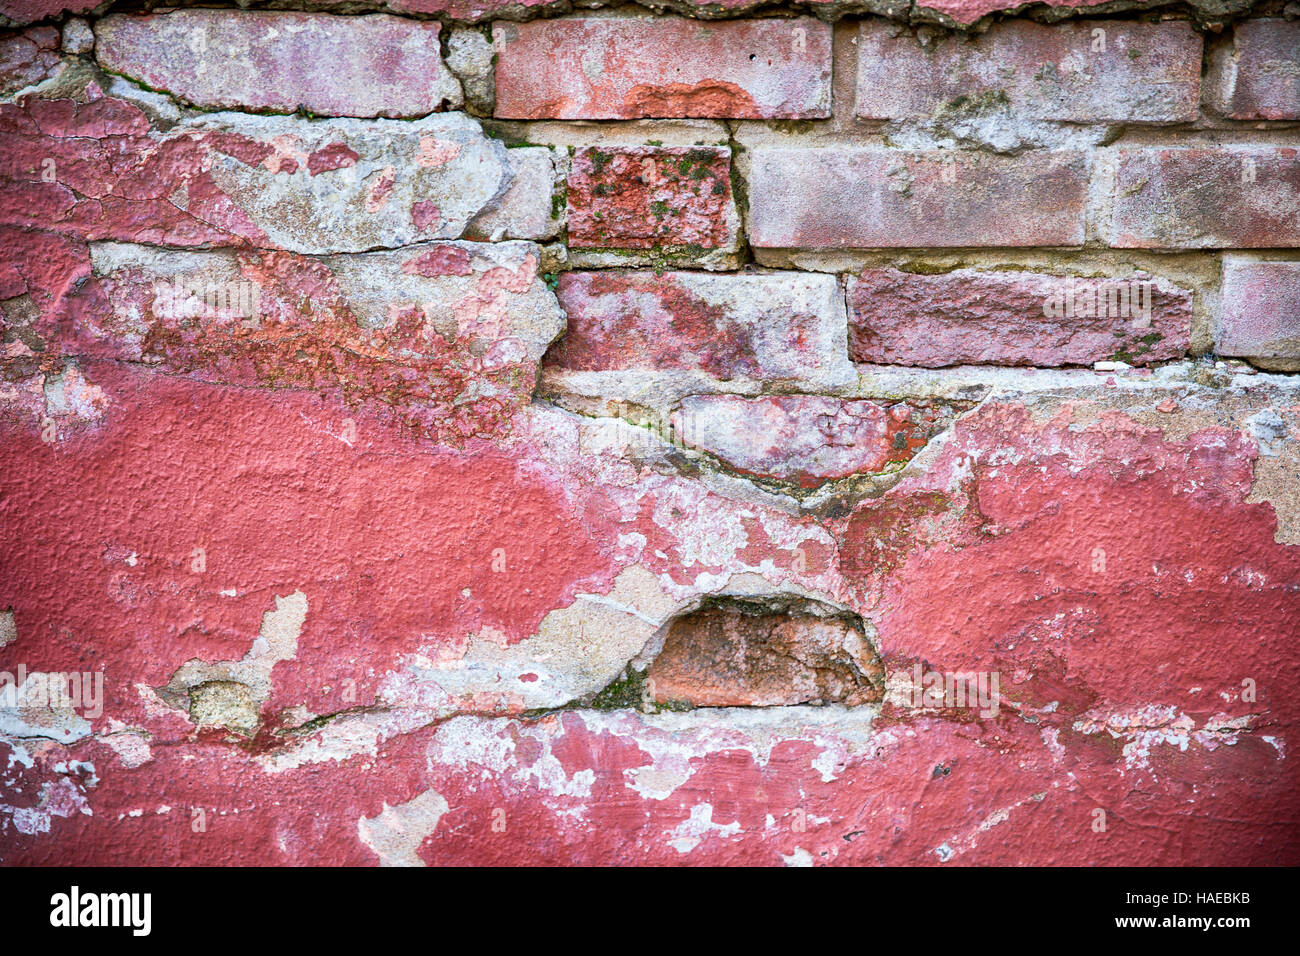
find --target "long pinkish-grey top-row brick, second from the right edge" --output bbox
[857,20,1201,122]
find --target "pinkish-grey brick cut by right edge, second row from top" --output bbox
[1110,146,1300,248]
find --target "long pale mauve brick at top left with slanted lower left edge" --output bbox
[95,9,462,117]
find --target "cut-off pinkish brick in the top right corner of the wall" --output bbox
[1208,20,1300,120]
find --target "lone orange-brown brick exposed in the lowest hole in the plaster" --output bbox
[646,601,884,708]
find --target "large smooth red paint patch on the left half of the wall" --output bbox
[0,365,624,727]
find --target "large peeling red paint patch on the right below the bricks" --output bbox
[844,405,1300,724]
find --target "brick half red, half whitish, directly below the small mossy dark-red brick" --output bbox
[547,271,853,388]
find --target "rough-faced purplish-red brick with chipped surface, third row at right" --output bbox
[849,269,1192,368]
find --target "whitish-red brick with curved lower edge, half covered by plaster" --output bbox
[675,395,945,488]
